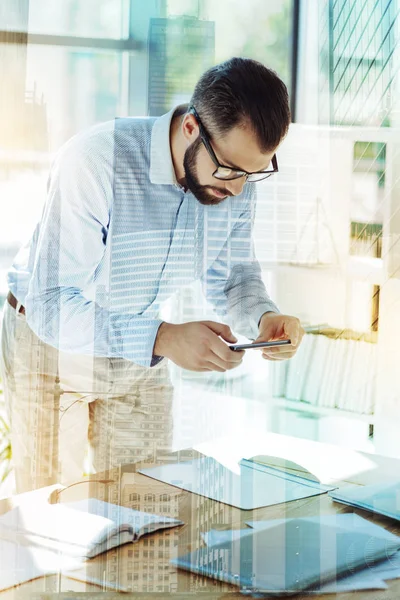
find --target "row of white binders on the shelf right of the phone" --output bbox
[272,327,378,425]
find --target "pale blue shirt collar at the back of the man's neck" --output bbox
[150,105,188,185]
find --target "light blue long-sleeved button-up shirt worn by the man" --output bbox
[8,109,279,366]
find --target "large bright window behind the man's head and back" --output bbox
[0,0,292,300]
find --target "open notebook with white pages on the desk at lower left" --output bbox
[0,498,183,558]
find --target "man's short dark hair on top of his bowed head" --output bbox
[189,57,290,153]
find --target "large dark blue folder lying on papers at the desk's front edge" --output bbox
[171,518,400,595]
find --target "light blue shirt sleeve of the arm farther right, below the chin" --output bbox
[202,184,280,339]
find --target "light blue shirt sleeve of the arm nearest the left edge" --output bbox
[25,135,162,367]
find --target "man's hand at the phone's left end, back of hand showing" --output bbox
[154,321,244,373]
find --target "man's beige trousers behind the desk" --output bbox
[0,302,173,493]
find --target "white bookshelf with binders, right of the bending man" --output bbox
[256,124,400,432]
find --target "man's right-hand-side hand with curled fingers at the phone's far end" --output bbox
[255,312,305,360]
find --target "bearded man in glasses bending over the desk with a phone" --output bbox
[2,58,304,491]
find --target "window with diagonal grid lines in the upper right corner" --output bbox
[324,0,399,127]
